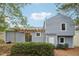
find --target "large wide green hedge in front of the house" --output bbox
[11,42,54,56]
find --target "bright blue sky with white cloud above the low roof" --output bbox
[22,3,58,27]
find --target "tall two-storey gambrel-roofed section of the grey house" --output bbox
[44,14,75,48]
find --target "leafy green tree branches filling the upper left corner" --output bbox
[0,3,27,31]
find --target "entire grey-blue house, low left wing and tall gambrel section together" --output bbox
[5,13,75,48]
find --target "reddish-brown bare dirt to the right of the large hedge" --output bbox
[54,48,79,56]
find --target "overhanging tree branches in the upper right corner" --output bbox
[56,3,79,25]
